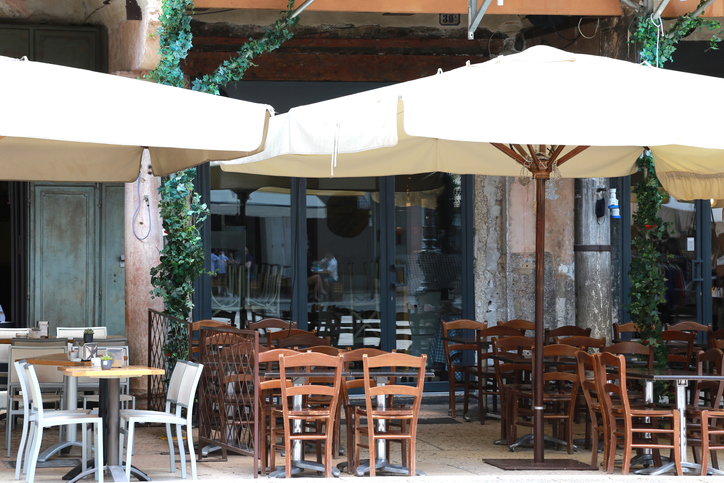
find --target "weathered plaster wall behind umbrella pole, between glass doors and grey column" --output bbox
[475,176,575,327]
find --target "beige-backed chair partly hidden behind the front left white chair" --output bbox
[5,345,68,457]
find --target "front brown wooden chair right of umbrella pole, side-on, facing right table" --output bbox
[594,352,682,475]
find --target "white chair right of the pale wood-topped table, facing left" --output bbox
[121,361,204,481]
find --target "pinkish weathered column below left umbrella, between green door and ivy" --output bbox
[124,155,163,395]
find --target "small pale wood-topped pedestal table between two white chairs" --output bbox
[58,366,166,483]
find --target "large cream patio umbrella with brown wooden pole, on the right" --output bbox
[220,46,724,467]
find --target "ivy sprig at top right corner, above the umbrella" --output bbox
[631,0,722,67]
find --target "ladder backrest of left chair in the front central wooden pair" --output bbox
[279,352,342,420]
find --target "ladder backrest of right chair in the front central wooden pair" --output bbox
[362,352,427,423]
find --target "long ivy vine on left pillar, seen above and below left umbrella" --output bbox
[146,0,299,369]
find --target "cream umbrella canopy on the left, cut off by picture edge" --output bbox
[0,57,273,182]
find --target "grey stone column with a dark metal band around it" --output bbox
[574,178,612,343]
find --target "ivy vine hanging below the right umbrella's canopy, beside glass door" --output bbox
[627,151,670,366]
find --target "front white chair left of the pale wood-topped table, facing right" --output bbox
[15,362,103,483]
